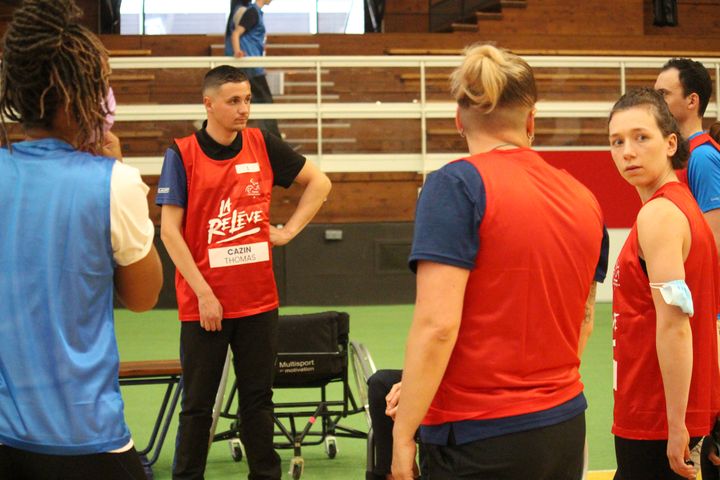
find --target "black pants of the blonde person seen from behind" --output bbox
[423,413,585,480]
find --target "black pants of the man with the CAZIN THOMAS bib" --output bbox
[173,309,281,480]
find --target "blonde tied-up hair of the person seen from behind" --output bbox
[450,45,537,115]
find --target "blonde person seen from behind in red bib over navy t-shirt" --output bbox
[392,45,607,480]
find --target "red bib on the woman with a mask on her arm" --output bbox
[612,182,720,440]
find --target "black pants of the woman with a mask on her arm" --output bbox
[614,436,704,480]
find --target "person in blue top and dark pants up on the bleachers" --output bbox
[225,0,282,138]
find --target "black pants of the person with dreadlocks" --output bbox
[0,445,147,480]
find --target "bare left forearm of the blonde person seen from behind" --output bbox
[392,261,470,480]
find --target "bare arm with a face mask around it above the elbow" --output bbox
[637,198,695,478]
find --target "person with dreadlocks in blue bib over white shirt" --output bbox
[0,0,162,480]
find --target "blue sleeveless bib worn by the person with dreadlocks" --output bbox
[0,139,130,455]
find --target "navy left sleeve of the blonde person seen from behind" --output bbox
[409,161,485,271]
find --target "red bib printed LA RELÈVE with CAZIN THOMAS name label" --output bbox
[175,128,278,321]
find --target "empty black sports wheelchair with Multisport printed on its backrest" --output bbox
[211,311,375,479]
